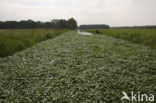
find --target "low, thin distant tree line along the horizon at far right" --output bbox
[112,25,156,29]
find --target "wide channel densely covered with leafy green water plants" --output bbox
[0,31,156,103]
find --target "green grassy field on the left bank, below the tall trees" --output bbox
[0,29,67,57]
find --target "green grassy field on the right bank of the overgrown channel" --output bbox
[87,29,156,48]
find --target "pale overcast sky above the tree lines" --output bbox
[0,0,156,26]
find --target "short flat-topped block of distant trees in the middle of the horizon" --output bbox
[79,24,110,29]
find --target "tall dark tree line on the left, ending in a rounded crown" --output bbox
[0,18,77,29]
